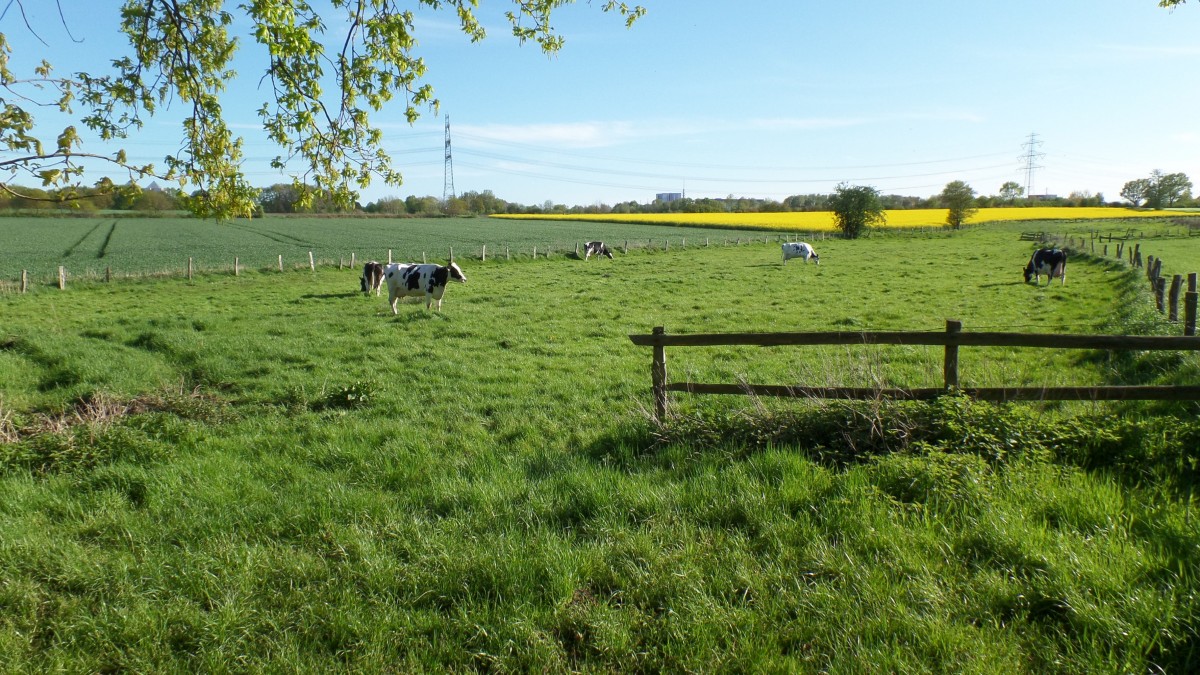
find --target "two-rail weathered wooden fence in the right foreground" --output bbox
[629,321,1200,420]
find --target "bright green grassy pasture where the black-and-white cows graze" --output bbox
[0,220,1200,673]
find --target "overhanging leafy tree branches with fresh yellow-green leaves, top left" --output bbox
[0,0,644,219]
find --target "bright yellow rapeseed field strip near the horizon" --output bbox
[492,207,1178,232]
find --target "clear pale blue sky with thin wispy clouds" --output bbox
[0,0,1200,205]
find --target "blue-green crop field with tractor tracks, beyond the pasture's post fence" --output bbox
[0,216,772,282]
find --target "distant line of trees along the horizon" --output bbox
[0,171,1200,216]
